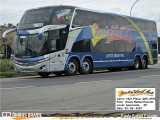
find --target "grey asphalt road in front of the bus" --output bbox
[0,64,160,116]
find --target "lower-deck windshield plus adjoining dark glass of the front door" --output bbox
[15,28,68,58]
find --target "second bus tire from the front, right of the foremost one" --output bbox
[79,58,92,74]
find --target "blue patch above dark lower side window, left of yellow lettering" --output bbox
[76,27,93,41]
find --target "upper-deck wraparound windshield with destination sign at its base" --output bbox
[19,7,73,29]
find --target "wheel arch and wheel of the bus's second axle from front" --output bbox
[79,57,93,74]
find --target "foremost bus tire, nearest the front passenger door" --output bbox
[66,59,78,75]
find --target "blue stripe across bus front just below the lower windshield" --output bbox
[15,56,44,63]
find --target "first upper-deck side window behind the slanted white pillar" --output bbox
[73,10,92,27]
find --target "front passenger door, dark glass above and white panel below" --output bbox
[49,28,68,72]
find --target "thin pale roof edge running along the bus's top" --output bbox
[27,5,155,22]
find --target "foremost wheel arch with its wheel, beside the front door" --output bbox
[65,57,80,75]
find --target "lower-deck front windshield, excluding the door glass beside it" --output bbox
[15,33,48,58]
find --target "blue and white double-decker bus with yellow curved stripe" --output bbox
[3,5,158,77]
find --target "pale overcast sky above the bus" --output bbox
[0,0,160,36]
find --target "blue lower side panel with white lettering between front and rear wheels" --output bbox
[65,52,136,70]
